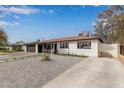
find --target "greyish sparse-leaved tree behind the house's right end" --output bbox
[94,10,113,43]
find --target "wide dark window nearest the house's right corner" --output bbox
[77,41,91,49]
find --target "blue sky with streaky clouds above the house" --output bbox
[0,5,108,43]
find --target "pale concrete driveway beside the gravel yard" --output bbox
[44,58,124,88]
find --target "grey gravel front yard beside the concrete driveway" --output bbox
[0,55,84,88]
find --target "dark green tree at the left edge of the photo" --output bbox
[0,29,8,46]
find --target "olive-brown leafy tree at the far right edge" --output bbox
[111,5,124,44]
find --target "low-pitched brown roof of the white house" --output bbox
[26,36,103,45]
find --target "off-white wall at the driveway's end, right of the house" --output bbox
[99,43,119,57]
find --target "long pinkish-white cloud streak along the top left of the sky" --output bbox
[0,6,55,16]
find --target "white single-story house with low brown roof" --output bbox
[24,36,103,57]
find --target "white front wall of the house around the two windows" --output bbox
[57,40,98,57]
